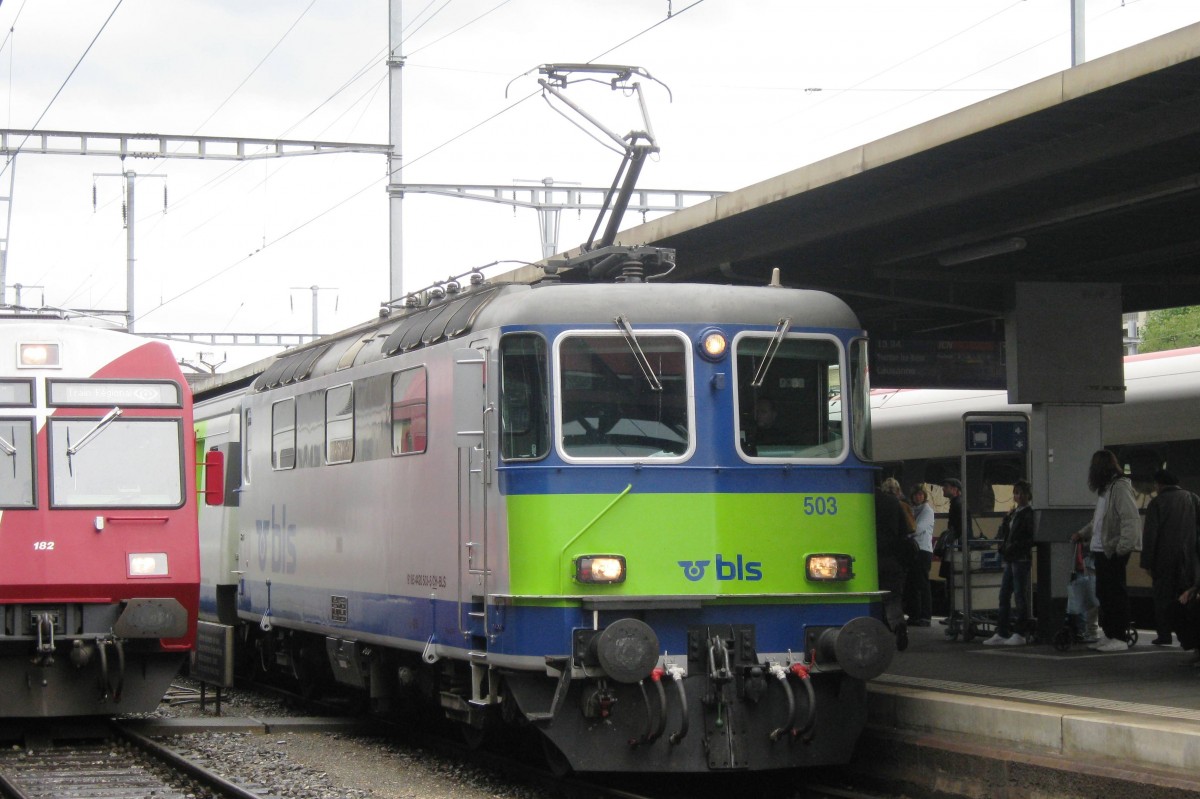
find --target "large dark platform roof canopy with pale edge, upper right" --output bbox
[600,24,1200,335]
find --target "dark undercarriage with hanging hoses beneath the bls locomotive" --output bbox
[241,607,890,773]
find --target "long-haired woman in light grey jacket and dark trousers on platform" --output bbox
[1072,450,1138,651]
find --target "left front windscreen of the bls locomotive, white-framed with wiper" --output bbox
[556,331,694,462]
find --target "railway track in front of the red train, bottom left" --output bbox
[0,722,270,799]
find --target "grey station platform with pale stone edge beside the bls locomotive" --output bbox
[864,619,1200,795]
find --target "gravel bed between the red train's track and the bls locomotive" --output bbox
[129,679,551,799]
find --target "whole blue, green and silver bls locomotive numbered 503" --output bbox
[197,248,894,773]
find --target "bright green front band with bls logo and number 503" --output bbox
[508,493,878,601]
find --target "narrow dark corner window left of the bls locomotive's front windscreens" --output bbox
[500,334,550,461]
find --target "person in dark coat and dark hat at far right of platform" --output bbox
[1139,469,1200,647]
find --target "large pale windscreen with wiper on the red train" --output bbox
[49,415,182,507]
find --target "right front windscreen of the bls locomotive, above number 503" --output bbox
[734,334,845,459]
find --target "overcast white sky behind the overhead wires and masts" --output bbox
[0,0,1200,365]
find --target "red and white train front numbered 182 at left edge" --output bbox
[0,319,202,717]
